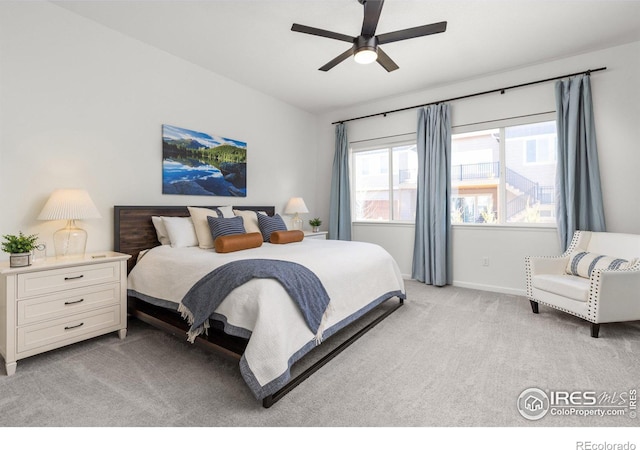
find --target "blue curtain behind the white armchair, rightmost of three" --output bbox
[556,74,605,249]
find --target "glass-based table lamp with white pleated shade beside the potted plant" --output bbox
[38,189,102,258]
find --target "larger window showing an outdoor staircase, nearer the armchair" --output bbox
[451,120,556,224]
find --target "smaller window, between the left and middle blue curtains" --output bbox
[351,142,418,222]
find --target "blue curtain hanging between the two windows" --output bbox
[411,104,452,286]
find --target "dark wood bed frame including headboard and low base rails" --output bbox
[113,206,404,408]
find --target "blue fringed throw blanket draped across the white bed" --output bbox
[178,259,330,342]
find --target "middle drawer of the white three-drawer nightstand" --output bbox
[17,284,120,326]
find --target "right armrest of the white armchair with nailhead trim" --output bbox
[589,262,640,323]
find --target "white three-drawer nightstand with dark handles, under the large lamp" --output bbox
[0,252,131,375]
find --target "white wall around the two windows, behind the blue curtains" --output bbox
[318,42,640,294]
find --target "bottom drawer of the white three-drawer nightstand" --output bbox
[16,305,120,353]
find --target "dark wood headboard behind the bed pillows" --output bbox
[113,205,275,273]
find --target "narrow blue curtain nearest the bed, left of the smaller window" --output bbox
[329,123,351,241]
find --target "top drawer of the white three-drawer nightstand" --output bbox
[18,262,120,299]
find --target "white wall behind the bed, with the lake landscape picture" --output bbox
[0,2,316,259]
